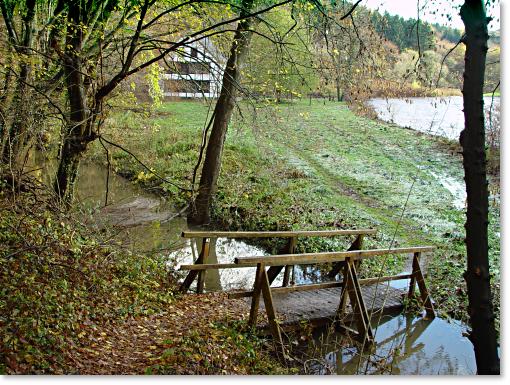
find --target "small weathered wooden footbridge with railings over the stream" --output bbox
[180,229,435,346]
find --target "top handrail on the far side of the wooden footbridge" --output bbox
[181,229,377,238]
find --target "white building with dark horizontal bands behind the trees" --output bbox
[163,38,225,98]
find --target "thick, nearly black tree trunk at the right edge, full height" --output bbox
[460,0,499,374]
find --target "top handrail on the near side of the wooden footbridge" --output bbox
[234,246,436,266]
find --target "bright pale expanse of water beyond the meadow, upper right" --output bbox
[368,96,500,140]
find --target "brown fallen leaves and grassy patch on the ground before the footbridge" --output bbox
[57,293,290,374]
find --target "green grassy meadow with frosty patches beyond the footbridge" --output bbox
[91,100,500,328]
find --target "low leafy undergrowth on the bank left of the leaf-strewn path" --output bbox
[0,191,174,373]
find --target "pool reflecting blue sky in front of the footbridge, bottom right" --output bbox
[306,314,476,375]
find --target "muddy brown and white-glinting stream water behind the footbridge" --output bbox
[33,154,281,291]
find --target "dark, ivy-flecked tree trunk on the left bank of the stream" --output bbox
[53,1,95,204]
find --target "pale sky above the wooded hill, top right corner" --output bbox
[361,0,500,30]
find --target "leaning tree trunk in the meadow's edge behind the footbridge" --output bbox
[188,0,253,225]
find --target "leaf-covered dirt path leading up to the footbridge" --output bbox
[66,293,255,375]
